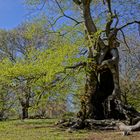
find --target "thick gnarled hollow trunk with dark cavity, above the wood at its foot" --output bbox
[75,0,138,120]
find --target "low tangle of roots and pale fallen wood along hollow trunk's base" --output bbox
[57,118,140,136]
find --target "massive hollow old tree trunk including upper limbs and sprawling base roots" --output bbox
[55,0,140,132]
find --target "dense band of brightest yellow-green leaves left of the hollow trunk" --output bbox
[0,30,83,88]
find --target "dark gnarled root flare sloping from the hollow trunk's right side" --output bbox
[104,98,140,122]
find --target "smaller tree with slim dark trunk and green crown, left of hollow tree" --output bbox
[0,16,83,119]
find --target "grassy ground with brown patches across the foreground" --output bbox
[0,119,140,140]
